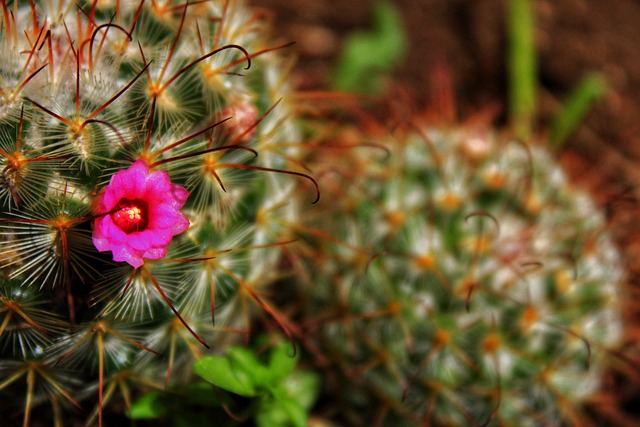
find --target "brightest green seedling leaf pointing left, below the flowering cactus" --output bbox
[193,356,257,397]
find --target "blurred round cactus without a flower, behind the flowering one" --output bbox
[294,110,623,426]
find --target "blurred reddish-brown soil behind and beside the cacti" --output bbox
[252,0,640,425]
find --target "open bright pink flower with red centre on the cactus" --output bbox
[93,160,189,268]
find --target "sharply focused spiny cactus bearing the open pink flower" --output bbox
[0,0,319,426]
